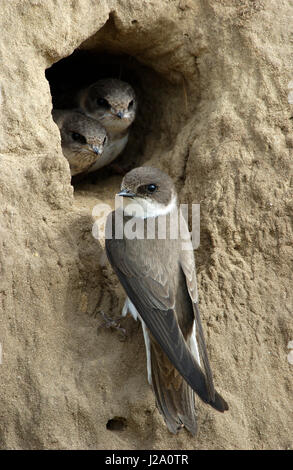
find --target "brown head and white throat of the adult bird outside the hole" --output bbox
[118,166,177,218]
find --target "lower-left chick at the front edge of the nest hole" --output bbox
[52,109,108,176]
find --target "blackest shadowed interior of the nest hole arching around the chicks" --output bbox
[46,50,170,182]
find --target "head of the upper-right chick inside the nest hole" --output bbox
[81,78,137,133]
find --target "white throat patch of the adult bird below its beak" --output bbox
[123,196,177,219]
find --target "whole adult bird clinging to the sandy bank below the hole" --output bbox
[105,167,228,435]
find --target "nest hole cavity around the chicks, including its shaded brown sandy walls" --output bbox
[46,23,194,206]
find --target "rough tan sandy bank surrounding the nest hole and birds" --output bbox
[0,0,293,449]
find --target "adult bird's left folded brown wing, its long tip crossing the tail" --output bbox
[106,212,227,411]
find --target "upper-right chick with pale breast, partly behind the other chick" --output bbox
[76,78,137,172]
